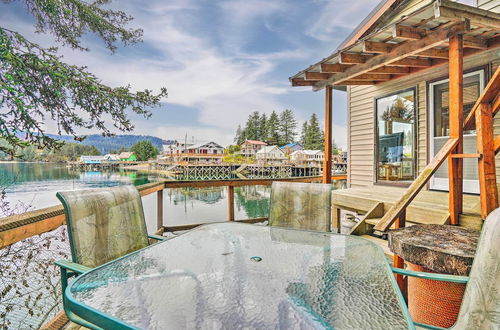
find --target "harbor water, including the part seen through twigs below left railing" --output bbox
[0,163,344,329]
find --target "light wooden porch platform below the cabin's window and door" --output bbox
[332,185,483,230]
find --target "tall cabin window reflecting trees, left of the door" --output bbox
[376,89,416,182]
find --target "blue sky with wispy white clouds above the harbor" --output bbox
[0,0,379,149]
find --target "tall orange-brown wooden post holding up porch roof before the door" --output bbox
[448,34,464,225]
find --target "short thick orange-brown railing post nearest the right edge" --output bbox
[476,103,498,219]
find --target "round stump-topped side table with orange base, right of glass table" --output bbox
[389,225,479,328]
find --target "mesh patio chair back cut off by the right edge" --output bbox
[453,208,500,329]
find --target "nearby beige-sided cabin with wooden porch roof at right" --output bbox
[290,0,500,228]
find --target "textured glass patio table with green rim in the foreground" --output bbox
[65,222,414,329]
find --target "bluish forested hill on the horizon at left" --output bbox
[47,134,167,155]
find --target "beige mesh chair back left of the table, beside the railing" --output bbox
[57,186,148,267]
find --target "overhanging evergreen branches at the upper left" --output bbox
[0,0,167,155]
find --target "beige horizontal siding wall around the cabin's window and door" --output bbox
[347,49,500,187]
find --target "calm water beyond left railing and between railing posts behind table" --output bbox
[0,163,280,231]
